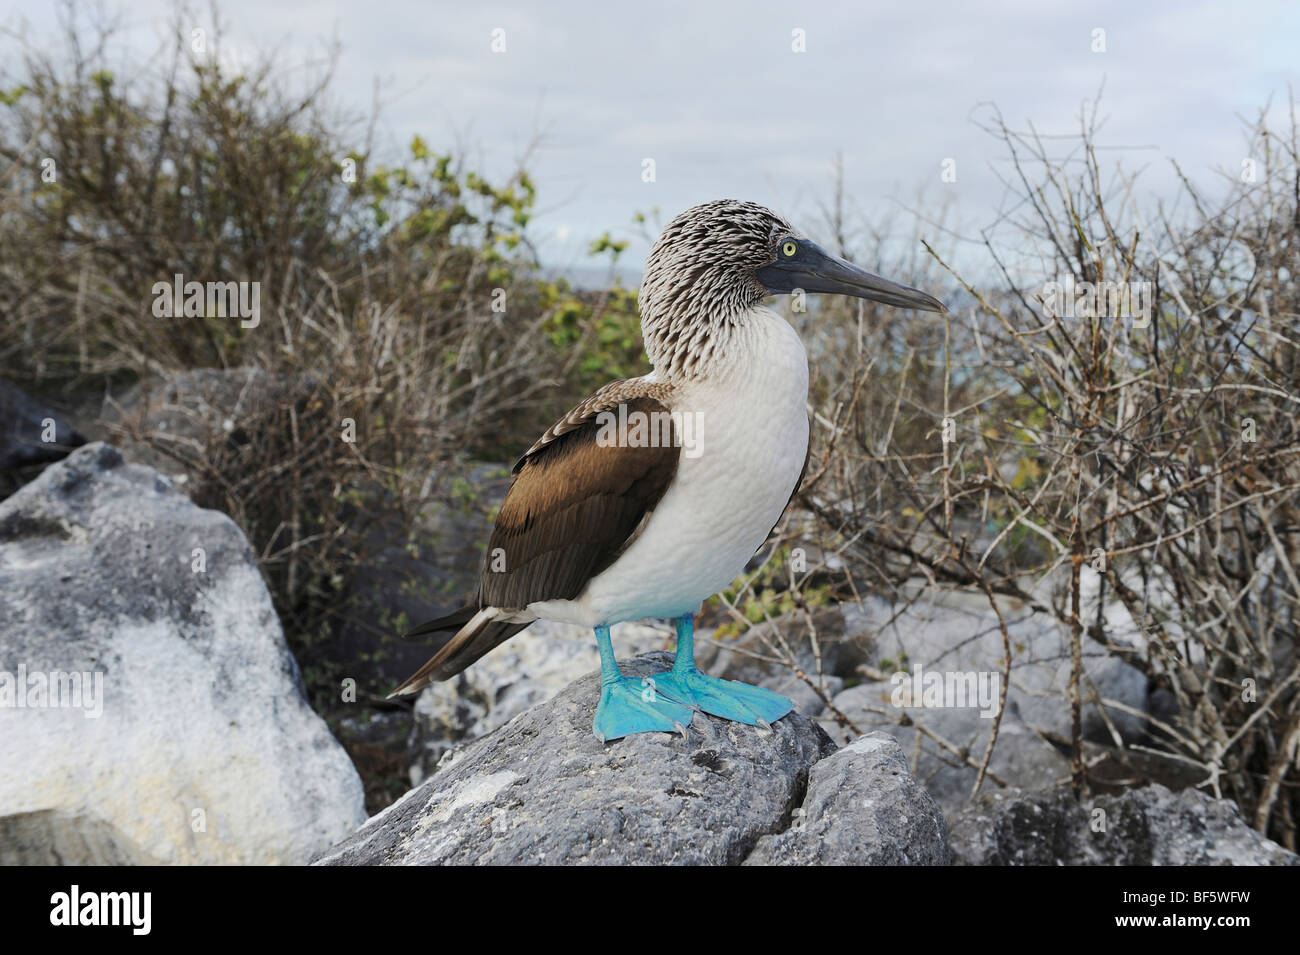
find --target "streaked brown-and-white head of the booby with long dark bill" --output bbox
[641,199,948,366]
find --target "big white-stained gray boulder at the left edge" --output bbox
[0,443,364,864]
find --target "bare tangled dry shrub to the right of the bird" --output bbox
[735,98,1300,848]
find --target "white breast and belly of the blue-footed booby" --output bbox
[529,308,809,626]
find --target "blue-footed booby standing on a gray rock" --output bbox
[393,199,946,741]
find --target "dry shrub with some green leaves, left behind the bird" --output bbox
[0,8,574,649]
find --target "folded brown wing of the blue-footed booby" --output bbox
[480,381,681,609]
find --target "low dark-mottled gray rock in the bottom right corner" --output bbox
[949,783,1300,865]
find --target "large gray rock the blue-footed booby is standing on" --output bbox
[317,652,835,865]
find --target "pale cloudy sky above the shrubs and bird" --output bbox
[0,0,1300,275]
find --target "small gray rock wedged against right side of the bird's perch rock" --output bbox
[745,733,949,865]
